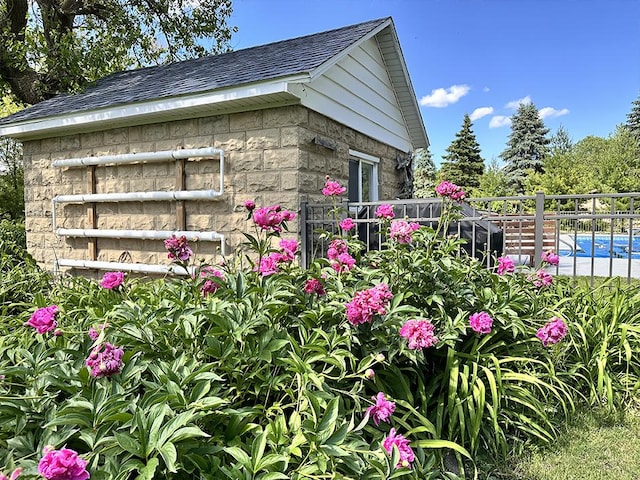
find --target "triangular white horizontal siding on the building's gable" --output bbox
[290,39,412,152]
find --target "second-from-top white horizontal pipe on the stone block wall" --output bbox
[53,190,222,203]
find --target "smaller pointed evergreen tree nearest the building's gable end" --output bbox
[440,113,484,190]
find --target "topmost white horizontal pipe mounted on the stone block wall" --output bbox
[51,147,223,168]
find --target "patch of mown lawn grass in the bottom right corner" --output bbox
[496,410,640,480]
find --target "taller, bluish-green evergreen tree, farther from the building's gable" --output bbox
[500,103,550,193]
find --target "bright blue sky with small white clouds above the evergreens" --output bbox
[230,0,640,164]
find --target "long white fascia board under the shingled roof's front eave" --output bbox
[0,75,309,138]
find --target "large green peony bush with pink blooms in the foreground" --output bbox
[0,186,637,480]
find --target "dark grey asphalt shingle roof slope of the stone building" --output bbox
[0,18,387,125]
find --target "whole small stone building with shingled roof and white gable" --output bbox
[0,18,428,273]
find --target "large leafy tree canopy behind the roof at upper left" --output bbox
[0,0,236,104]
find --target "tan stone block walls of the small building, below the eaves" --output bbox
[24,106,408,273]
